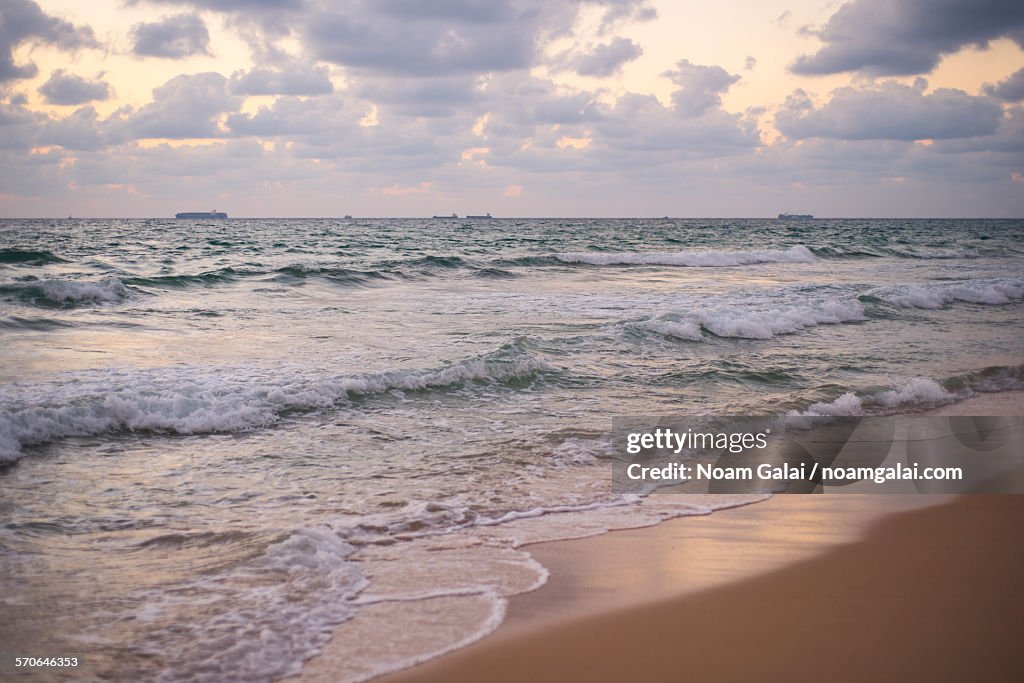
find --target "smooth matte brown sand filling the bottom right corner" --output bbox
[379,495,1024,683]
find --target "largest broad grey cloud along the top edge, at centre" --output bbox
[130,0,656,78]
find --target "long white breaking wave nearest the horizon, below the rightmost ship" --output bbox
[556,245,817,267]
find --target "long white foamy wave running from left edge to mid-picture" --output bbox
[0,343,549,463]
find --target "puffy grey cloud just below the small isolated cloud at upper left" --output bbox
[116,72,242,139]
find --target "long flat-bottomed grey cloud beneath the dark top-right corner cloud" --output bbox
[775,78,1002,140]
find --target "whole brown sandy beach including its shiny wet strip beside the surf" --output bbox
[319,391,1024,683]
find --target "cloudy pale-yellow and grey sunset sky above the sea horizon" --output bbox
[0,0,1024,217]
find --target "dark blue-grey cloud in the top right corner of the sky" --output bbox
[791,0,1024,76]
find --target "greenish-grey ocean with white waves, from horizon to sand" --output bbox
[0,219,1024,682]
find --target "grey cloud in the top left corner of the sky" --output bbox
[0,0,97,82]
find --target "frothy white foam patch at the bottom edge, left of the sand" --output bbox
[144,528,368,683]
